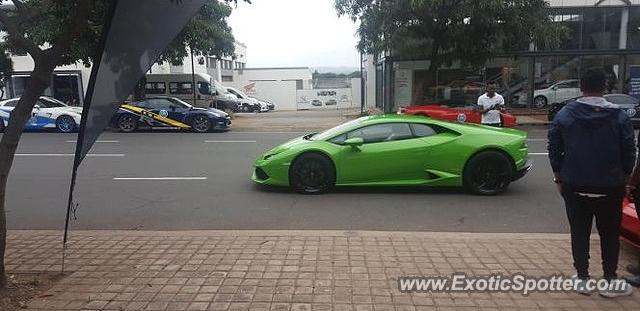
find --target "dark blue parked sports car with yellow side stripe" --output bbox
[110,96,231,133]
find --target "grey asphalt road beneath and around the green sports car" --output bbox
[2,127,567,232]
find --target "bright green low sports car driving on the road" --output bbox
[251,115,531,195]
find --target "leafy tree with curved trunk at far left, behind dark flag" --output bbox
[0,0,249,289]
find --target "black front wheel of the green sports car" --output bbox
[289,153,336,194]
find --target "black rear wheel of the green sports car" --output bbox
[463,151,513,195]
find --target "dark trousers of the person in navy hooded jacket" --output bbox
[562,185,625,279]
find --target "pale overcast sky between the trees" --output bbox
[229,0,360,67]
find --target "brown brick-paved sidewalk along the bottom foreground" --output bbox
[6,231,640,310]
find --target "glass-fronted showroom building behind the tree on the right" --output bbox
[363,0,640,112]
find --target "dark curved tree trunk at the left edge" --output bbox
[0,64,55,289]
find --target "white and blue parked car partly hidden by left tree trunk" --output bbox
[0,96,82,133]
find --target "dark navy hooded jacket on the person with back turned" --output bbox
[548,98,636,192]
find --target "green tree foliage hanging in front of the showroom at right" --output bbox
[335,0,564,67]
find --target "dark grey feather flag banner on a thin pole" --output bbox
[63,0,205,266]
